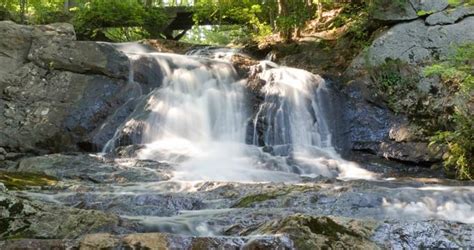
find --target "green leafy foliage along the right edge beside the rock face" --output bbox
[425,44,474,180]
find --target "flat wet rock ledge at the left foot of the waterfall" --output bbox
[15,154,171,183]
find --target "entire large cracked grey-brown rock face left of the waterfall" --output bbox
[0,21,143,153]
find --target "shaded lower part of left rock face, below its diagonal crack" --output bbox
[0,63,133,152]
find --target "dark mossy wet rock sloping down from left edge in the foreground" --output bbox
[0,193,126,239]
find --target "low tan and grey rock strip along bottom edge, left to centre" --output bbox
[0,233,293,250]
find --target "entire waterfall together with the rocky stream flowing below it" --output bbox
[0,44,474,249]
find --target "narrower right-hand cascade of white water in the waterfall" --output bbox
[253,61,373,179]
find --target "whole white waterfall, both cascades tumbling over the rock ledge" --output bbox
[107,49,372,181]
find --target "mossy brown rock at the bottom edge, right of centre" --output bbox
[254,214,378,249]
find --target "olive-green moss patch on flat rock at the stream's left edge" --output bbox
[0,171,57,190]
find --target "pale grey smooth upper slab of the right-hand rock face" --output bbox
[346,17,474,72]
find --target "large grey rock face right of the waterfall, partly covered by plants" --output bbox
[343,12,474,164]
